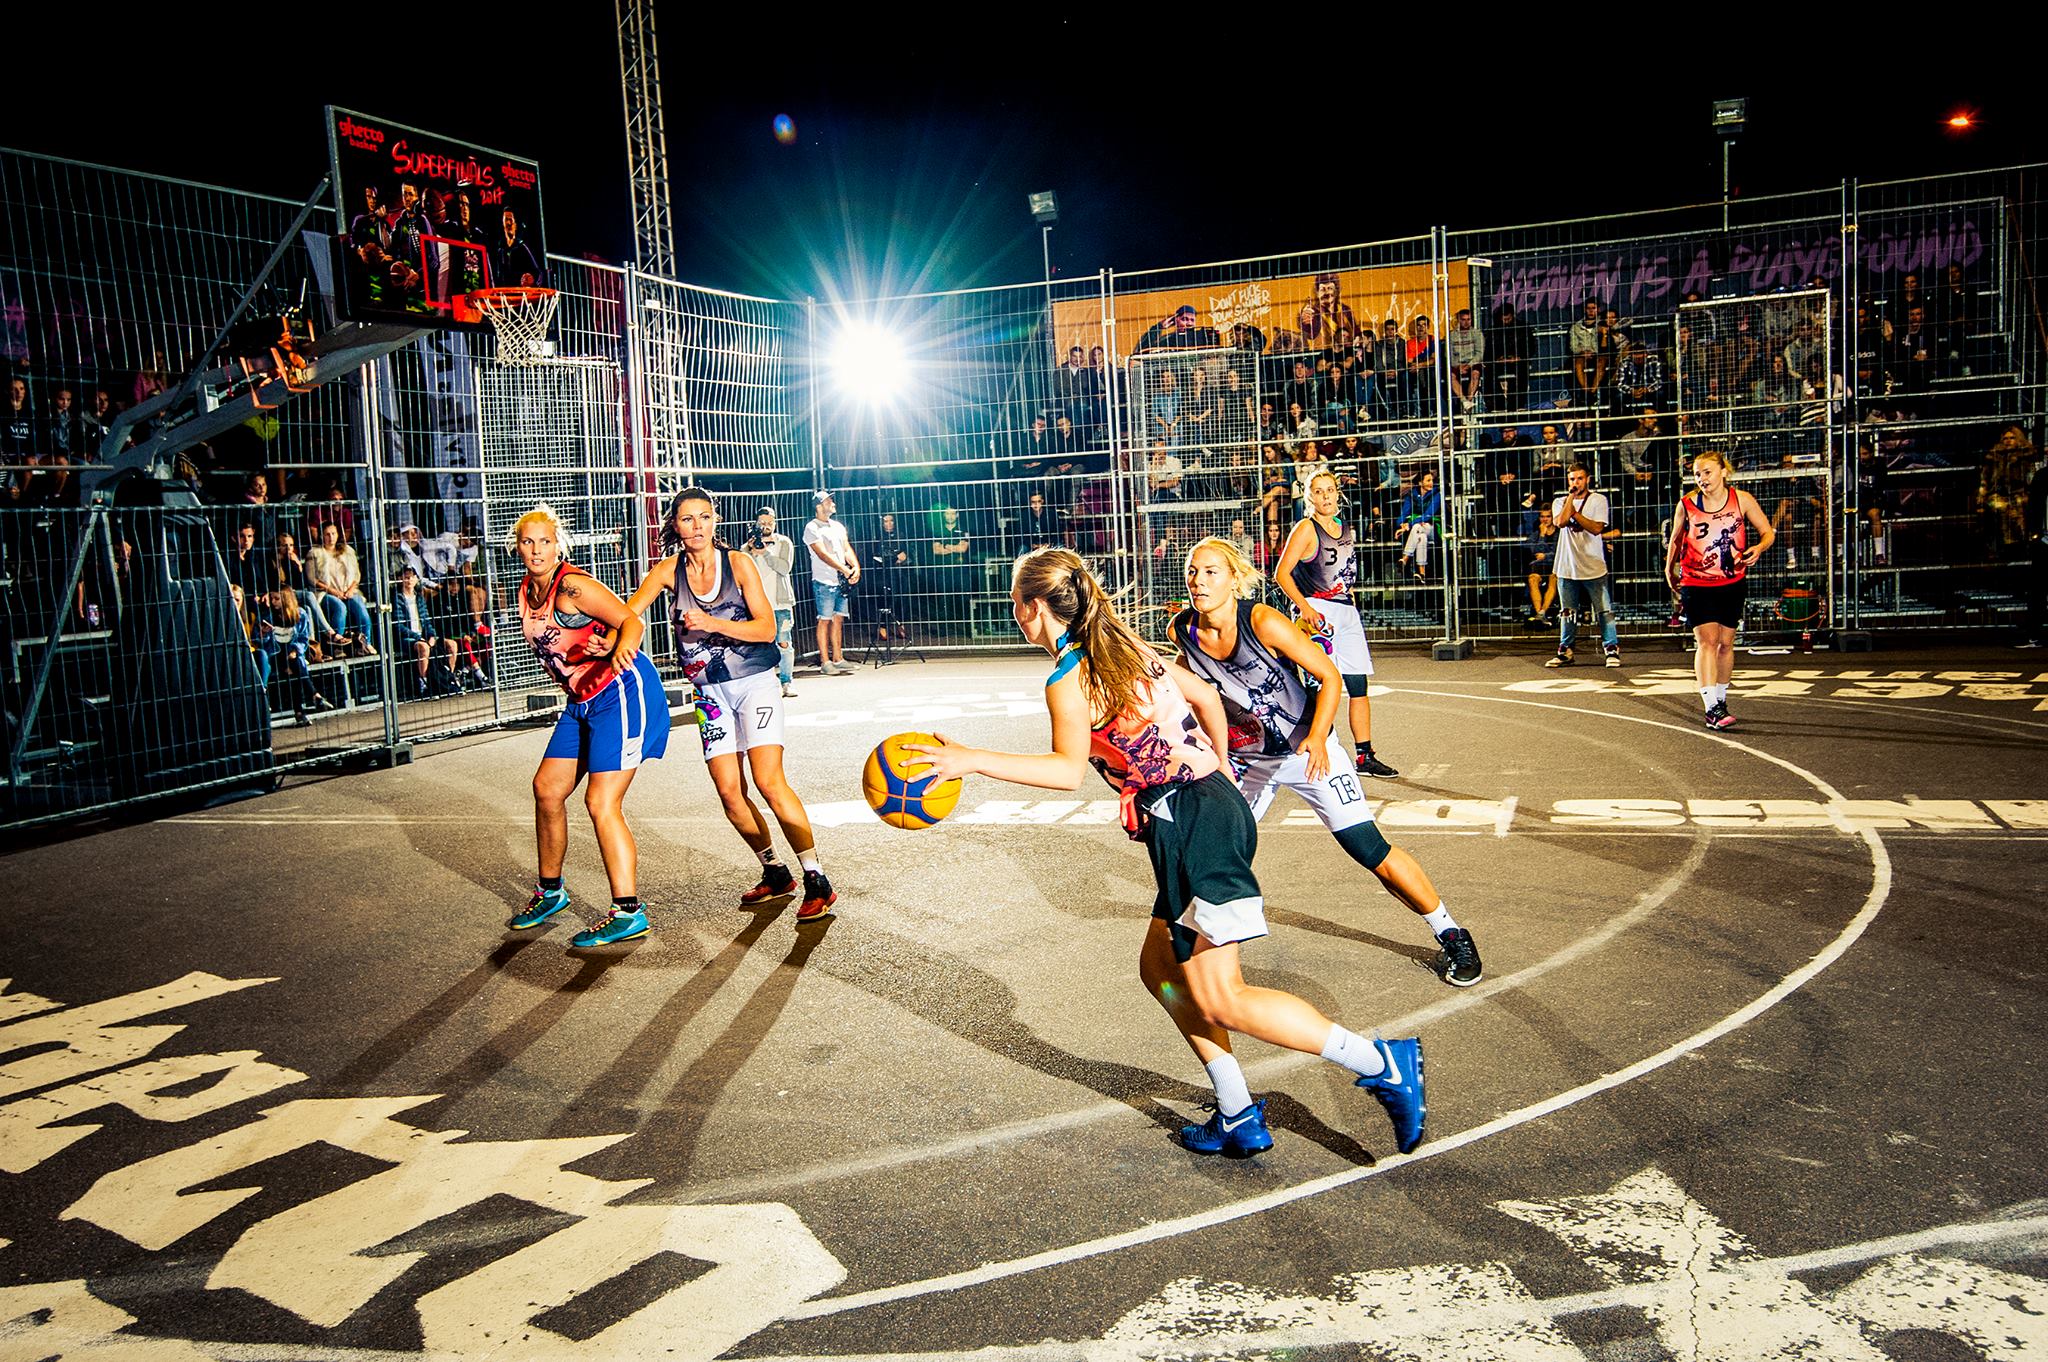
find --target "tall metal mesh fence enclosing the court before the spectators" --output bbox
[0,152,2048,825]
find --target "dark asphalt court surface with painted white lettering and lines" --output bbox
[0,647,2048,1362]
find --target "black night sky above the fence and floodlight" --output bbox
[0,18,2048,297]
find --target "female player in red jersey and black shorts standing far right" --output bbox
[1665,449,1778,729]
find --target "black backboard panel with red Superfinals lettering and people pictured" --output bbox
[328,104,547,324]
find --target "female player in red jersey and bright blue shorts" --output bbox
[506,502,668,946]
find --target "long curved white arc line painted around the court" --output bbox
[786,690,1892,1319]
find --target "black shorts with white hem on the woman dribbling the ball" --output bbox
[1143,770,1266,965]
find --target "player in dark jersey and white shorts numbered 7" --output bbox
[627,487,840,922]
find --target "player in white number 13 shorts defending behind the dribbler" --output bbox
[1169,539,1481,989]
